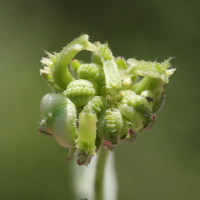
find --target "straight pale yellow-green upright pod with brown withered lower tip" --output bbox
[76,102,97,165]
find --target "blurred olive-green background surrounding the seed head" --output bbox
[0,0,200,200]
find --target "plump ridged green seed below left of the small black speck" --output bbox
[118,95,152,131]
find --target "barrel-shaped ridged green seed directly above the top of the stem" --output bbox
[97,108,124,145]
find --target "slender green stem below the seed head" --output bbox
[94,149,109,200]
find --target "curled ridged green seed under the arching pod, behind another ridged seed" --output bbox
[77,63,105,91]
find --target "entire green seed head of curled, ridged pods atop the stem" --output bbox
[38,35,175,165]
